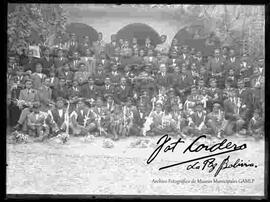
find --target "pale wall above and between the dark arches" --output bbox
[63,5,192,43]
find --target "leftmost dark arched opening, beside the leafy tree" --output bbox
[66,23,98,44]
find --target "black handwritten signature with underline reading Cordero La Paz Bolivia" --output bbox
[147,134,257,177]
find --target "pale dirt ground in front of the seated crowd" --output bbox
[6,137,264,196]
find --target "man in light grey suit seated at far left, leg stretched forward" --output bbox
[13,80,39,133]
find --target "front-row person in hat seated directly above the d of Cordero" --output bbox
[206,102,226,137]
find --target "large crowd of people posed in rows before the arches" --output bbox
[7,33,265,140]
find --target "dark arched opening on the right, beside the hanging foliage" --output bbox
[174,24,220,56]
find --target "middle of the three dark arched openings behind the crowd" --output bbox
[116,23,161,45]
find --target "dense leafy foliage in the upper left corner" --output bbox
[7,4,67,52]
